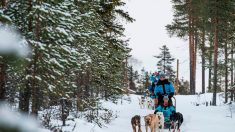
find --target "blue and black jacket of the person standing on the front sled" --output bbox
[154,79,175,95]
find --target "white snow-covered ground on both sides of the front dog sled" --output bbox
[74,94,235,132]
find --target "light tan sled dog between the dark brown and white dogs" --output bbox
[144,114,160,132]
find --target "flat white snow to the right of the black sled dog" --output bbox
[176,95,235,132]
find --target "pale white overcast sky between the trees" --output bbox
[124,0,207,91]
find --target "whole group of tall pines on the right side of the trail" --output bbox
[166,0,235,105]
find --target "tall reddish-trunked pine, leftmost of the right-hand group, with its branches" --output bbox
[166,0,200,94]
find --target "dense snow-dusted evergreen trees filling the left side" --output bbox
[0,0,134,127]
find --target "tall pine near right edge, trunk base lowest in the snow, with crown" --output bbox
[208,0,234,105]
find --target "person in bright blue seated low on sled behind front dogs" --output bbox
[154,96,175,122]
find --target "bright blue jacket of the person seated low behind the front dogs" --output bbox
[156,105,175,122]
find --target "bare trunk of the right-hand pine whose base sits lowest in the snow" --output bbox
[212,17,219,106]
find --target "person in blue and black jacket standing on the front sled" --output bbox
[154,72,175,105]
